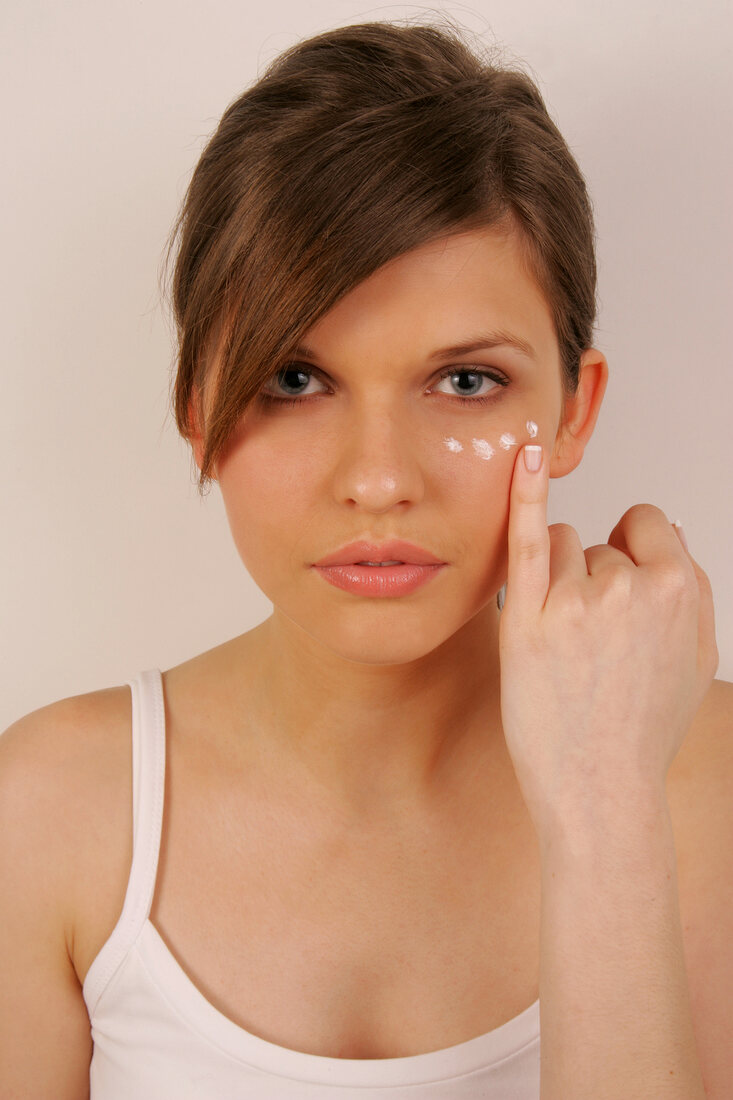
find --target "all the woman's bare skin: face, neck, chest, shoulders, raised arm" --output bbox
[0,218,733,1100]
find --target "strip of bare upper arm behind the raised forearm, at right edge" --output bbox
[667,680,733,1098]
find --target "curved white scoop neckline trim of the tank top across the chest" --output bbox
[135,919,539,1087]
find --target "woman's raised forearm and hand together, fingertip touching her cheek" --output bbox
[500,442,718,1100]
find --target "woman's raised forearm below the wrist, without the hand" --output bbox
[539,795,704,1100]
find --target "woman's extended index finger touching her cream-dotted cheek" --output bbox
[506,444,550,615]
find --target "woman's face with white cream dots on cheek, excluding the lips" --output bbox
[211,229,562,664]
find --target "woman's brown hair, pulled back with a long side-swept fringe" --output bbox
[159,22,595,490]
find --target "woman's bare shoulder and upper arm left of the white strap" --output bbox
[0,688,131,1100]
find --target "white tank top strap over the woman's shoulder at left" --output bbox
[84,669,165,1012]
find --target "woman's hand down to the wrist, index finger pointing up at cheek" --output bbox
[500,449,719,835]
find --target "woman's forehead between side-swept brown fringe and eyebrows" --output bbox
[304,227,558,359]
